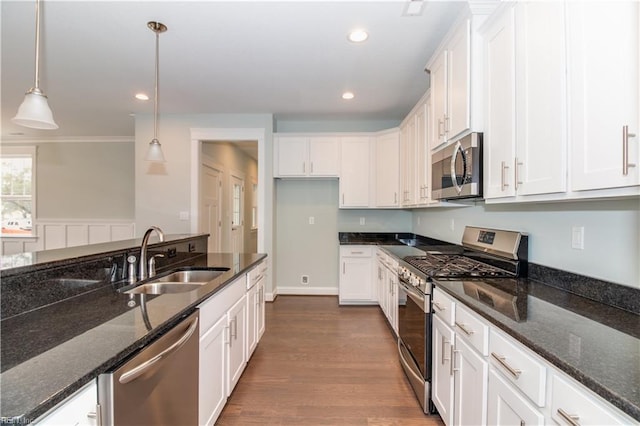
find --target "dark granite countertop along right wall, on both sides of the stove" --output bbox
[339,233,640,421]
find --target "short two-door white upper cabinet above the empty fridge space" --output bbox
[274,135,340,177]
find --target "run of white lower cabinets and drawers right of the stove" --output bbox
[431,288,638,426]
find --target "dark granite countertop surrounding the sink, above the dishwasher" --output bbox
[0,253,266,423]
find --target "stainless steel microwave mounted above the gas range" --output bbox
[431,133,482,200]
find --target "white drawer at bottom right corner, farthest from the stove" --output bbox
[551,372,632,425]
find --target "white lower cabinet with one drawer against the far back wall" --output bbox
[338,245,377,305]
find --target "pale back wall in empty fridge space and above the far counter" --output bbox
[276,179,411,294]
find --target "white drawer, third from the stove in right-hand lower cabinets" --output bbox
[489,329,547,407]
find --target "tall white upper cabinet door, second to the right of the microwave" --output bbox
[516,2,567,195]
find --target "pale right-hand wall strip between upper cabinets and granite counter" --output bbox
[413,199,640,287]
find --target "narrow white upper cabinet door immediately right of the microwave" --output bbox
[483,7,515,198]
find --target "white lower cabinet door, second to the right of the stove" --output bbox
[453,335,489,425]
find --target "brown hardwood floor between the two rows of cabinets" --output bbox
[216,296,442,426]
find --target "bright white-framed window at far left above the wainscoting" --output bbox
[0,147,36,237]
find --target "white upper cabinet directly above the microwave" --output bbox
[427,7,485,148]
